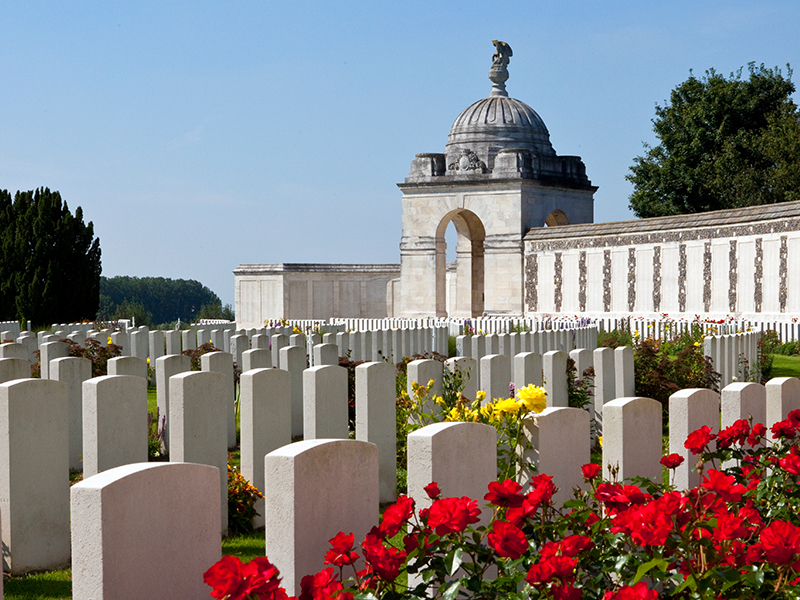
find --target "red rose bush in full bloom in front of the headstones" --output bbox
[205,411,800,600]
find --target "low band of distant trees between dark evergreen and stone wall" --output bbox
[98,277,227,325]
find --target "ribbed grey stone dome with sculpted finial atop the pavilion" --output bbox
[445,40,556,171]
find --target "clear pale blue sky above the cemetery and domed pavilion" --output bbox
[0,0,800,303]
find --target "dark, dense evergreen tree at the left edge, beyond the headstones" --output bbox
[0,188,101,325]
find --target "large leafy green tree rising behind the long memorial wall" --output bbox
[626,63,800,217]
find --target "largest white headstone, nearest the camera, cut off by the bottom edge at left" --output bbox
[67,463,222,600]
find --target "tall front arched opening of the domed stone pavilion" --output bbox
[435,208,486,317]
